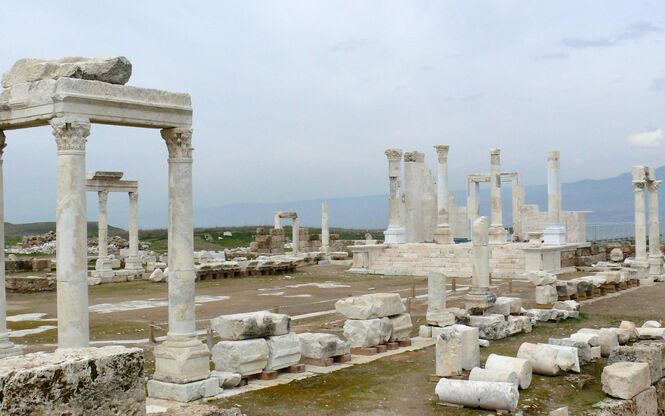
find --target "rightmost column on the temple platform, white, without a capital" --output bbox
[543,150,566,246]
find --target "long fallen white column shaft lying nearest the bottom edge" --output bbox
[435,378,520,412]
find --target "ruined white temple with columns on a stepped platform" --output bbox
[350,145,590,277]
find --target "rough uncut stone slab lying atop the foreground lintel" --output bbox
[2,56,132,88]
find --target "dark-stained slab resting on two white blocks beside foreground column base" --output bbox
[210,311,291,340]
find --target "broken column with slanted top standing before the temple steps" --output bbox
[464,216,496,315]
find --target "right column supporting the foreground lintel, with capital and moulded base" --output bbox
[153,128,210,384]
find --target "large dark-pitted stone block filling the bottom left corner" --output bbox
[0,346,145,416]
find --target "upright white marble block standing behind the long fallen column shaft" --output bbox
[436,325,480,377]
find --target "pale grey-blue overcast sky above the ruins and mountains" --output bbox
[0,0,665,227]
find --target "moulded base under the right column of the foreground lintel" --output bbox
[153,335,210,384]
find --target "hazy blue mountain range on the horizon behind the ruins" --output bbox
[189,166,665,229]
